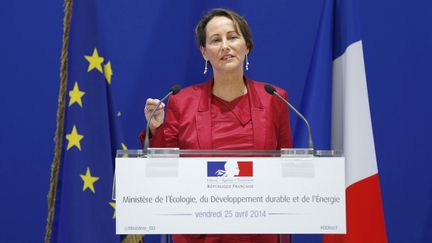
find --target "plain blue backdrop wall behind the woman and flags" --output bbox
[0,0,432,242]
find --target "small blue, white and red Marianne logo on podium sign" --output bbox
[207,161,253,177]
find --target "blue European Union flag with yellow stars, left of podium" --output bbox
[47,1,142,243]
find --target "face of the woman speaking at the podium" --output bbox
[201,16,249,73]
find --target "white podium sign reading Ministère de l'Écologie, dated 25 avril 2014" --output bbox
[116,153,346,234]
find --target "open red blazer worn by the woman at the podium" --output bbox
[140,78,292,150]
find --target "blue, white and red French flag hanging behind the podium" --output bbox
[295,0,387,243]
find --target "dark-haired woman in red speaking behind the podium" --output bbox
[140,9,292,243]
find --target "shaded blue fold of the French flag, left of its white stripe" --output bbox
[294,1,333,150]
